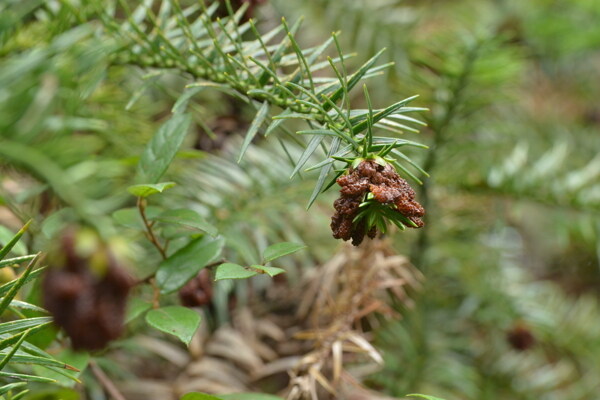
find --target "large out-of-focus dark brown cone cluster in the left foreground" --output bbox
[42,230,133,350]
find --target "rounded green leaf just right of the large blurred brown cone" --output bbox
[146,306,200,345]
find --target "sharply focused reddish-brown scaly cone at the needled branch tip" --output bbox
[331,160,425,246]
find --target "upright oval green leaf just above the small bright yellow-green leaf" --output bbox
[138,113,192,183]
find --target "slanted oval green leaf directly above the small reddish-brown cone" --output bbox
[156,236,225,293]
